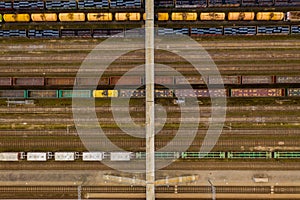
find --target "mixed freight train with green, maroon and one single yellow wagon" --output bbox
[0,88,300,99]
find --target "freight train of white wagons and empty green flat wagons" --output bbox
[0,151,300,162]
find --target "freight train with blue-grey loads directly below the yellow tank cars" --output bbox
[0,25,300,38]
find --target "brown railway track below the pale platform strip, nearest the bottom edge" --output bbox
[0,186,300,194]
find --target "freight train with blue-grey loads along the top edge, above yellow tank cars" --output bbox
[0,0,300,10]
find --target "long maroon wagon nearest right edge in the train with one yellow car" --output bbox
[230,88,285,97]
